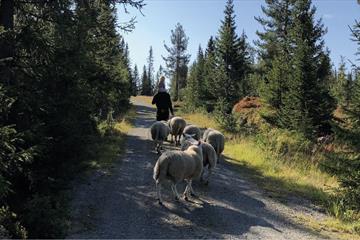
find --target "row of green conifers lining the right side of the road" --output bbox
[146,0,360,221]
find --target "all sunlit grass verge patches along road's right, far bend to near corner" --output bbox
[181,109,360,239]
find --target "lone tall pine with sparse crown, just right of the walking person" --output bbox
[162,23,190,100]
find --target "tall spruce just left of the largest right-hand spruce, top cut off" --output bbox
[255,0,295,110]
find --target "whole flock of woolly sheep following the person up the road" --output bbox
[150,117,225,204]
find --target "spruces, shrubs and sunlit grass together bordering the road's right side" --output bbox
[172,0,360,236]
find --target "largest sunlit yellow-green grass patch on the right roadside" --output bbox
[224,139,337,202]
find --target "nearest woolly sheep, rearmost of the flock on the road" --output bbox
[153,140,203,205]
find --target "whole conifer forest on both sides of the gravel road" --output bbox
[0,0,360,238]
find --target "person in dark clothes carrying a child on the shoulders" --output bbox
[152,76,174,121]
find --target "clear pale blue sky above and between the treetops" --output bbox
[117,0,360,81]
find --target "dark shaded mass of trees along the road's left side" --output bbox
[0,0,144,238]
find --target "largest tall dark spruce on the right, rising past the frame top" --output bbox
[279,0,335,138]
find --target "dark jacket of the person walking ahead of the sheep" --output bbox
[152,92,174,121]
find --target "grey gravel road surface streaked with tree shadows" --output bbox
[67,98,334,240]
